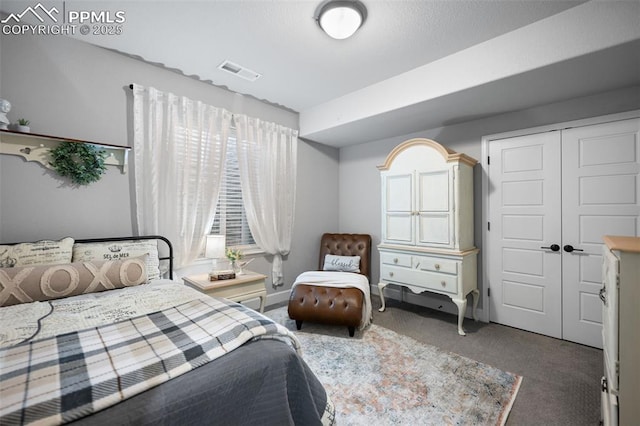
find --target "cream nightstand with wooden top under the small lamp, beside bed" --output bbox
[182,271,267,312]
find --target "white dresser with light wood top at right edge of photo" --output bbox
[600,236,640,425]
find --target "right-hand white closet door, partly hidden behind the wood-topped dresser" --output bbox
[562,119,640,347]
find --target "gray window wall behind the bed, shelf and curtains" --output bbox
[0,31,338,298]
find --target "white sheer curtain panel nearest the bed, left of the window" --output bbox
[133,84,231,268]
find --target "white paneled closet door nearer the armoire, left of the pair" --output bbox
[487,132,562,337]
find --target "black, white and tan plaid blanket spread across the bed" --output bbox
[0,298,299,425]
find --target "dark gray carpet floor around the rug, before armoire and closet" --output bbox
[272,296,603,425]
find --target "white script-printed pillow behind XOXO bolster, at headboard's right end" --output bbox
[73,240,160,280]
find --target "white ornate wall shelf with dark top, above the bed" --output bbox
[0,130,131,174]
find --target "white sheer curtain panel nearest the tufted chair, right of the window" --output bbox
[233,114,298,286]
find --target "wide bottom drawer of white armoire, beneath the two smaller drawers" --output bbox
[380,264,458,294]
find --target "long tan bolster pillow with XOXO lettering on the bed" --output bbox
[0,255,148,306]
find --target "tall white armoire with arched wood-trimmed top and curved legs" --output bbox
[378,138,478,336]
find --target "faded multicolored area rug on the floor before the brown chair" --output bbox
[265,307,522,426]
